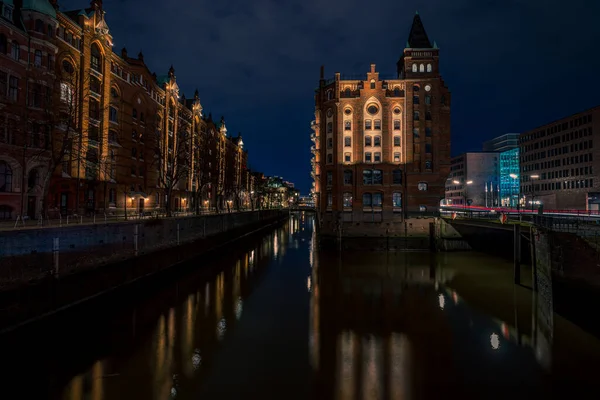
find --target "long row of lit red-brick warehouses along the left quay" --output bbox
[0,0,251,219]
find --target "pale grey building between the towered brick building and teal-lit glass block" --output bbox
[445,152,501,207]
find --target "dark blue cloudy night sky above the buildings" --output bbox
[59,0,600,194]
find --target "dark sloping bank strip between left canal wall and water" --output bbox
[0,210,289,330]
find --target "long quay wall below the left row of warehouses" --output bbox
[0,210,288,289]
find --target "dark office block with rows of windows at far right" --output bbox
[519,106,600,210]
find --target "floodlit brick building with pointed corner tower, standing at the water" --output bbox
[311,14,450,236]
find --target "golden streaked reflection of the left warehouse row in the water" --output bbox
[60,223,280,400]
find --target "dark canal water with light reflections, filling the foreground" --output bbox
[0,213,600,400]
